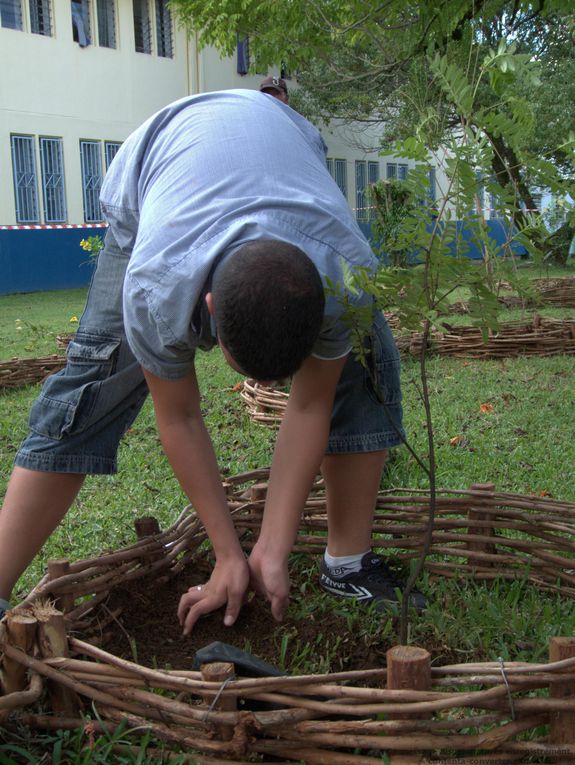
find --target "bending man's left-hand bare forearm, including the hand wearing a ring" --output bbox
[144,370,249,634]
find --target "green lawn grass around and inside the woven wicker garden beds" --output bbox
[0,272,575,765]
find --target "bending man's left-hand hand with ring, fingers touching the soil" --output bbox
[178,558,250,635]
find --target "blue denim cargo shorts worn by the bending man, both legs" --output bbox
[15,231,402,474]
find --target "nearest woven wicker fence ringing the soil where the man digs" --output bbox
[0,471,575,765]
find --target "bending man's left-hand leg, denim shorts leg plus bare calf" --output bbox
[0,231,147,610]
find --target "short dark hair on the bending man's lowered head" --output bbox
[212,239,325,380]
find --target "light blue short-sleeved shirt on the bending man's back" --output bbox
[101,90,376,379]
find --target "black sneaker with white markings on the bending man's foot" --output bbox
[319,552,427,611]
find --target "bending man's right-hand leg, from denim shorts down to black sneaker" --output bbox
[320,314,425,610]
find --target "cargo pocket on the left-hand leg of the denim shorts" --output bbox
[30,331,121,440]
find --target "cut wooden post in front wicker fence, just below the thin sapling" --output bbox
[386,645,431,765]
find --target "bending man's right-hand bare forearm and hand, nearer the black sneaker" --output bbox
[249,357,346,619]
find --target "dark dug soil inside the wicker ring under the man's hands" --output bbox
[102,556,410,674]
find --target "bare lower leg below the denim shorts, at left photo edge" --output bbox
[0,467,84,600]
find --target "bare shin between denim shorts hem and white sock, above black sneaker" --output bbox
[321,449,387,557]
